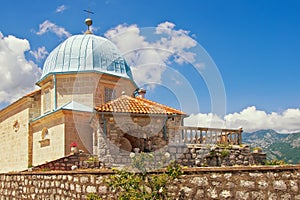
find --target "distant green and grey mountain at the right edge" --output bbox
[243,129,300,164]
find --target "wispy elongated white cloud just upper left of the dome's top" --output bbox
[36,20,71,38]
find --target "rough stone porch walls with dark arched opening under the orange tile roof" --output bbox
[93,113,182,166]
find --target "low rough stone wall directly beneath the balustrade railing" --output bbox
[166,145,266,167]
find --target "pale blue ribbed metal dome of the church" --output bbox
[40,34,133,80]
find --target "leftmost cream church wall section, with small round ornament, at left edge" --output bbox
[0,92,39,172]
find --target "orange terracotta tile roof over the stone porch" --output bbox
[95,95,186,115]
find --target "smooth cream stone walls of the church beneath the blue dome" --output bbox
[0,73,135,172]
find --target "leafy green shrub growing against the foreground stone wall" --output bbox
[101,153,183,200]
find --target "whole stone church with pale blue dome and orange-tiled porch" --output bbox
[0,19,186,172]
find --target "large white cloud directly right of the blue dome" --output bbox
[105,22,197,85]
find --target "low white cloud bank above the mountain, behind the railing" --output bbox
[185,106,300,133]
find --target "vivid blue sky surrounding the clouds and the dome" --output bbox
[0,0,300,132]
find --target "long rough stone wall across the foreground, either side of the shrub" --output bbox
[0,166,300,200]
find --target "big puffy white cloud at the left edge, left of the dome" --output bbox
[0,32,41,105]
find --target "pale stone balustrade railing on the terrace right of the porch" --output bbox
[169,126,243,145]
